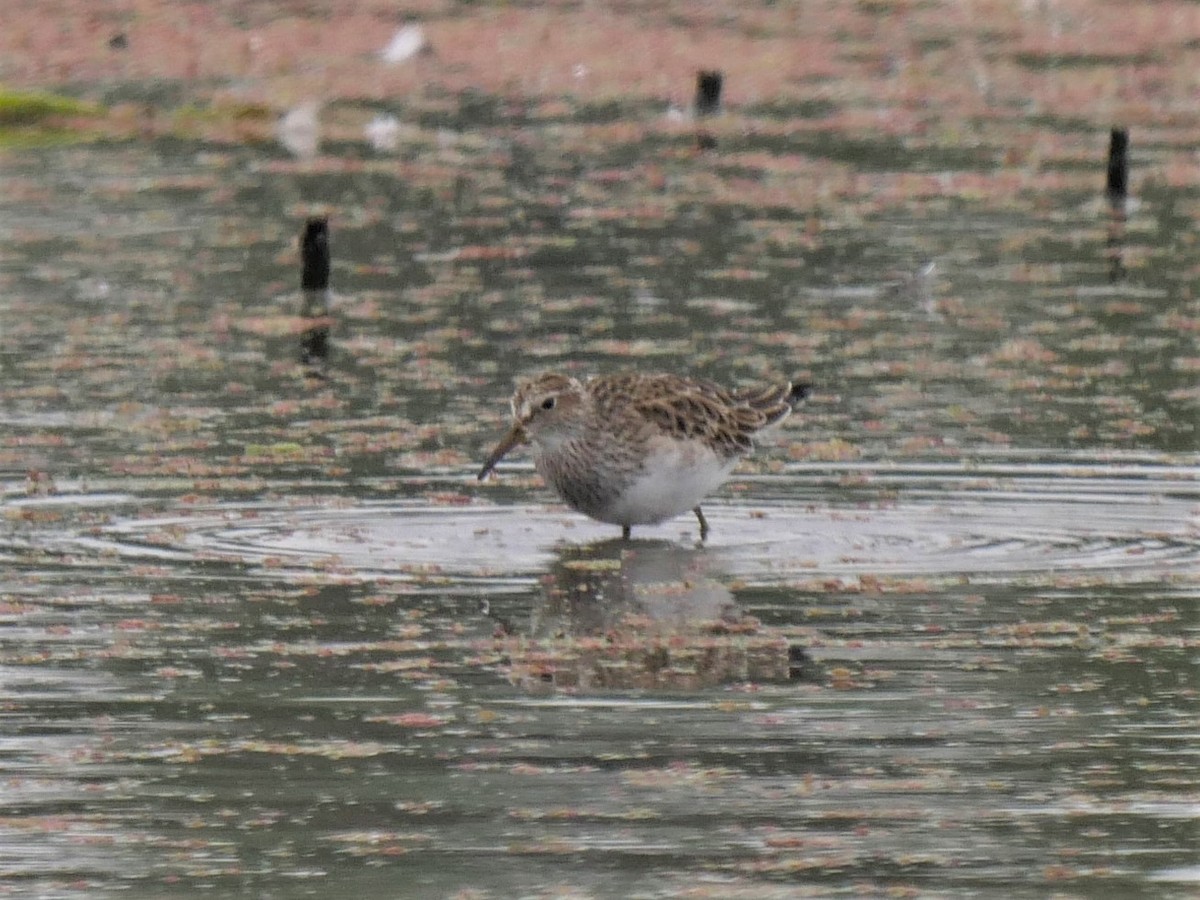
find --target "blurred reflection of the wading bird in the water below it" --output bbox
[499,540,810,690]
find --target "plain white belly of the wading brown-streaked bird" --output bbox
[595,440,737,526]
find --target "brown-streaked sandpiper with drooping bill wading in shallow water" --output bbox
[479,372,809,540]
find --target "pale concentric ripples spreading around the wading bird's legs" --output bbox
[65,467,1200,581]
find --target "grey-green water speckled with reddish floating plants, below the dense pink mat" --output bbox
[0,95,1200,900]
